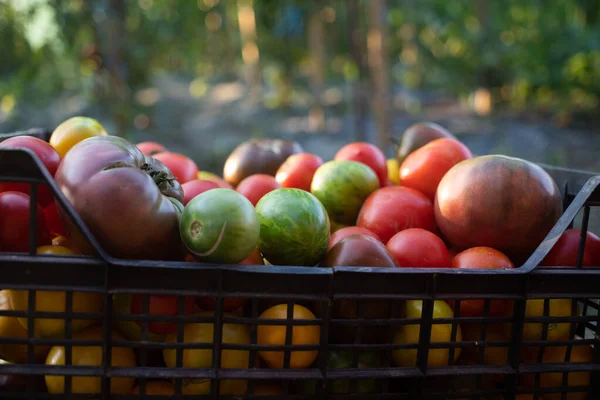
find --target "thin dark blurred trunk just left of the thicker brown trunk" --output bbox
[345,0,367,141]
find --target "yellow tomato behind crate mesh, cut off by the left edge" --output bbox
[0,290,50,364]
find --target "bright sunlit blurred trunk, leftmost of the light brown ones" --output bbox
[238,0,261,102]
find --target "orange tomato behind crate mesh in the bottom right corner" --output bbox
[522,345,593,400]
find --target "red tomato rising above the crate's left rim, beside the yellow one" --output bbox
[0,136,60,207]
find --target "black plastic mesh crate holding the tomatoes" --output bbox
[0,130,600,400]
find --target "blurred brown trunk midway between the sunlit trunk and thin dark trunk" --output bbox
[308,0,325,132]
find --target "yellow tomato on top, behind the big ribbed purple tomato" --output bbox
[49,117,108,158]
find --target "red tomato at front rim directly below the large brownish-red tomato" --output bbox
[448,246,515,317]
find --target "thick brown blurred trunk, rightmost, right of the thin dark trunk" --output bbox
[367,0,390,151]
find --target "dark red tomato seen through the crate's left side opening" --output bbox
[0,192,52,252]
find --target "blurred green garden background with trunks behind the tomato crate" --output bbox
[0,0,600,172]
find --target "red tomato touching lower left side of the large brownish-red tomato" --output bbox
[356,186,436,243]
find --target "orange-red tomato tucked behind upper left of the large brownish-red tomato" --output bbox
[400,138,473,201]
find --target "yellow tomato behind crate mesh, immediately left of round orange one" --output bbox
[163,313,250,396]
